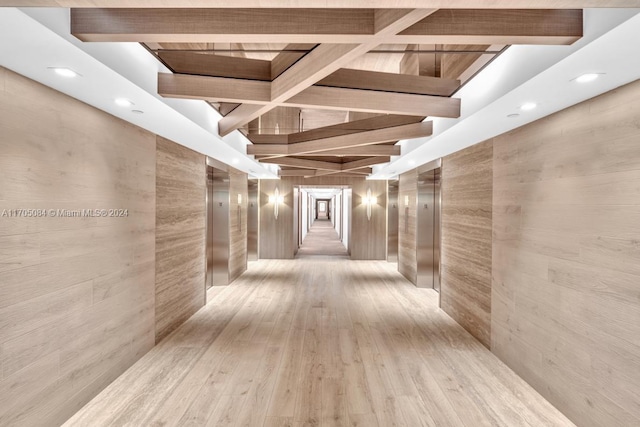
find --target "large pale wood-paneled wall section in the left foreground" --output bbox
[0,68,155,426]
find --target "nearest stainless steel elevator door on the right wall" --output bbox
[416,169,440,291]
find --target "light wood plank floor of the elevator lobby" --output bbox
[66,257,573,427]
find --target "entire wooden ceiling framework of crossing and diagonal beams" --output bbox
[63,8,583,177]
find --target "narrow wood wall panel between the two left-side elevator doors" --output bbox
[229,168,249,283]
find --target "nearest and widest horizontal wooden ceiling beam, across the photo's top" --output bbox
[71,8,586,45]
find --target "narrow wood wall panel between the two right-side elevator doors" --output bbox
[398,169,418,285]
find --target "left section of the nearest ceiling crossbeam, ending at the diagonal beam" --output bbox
[71,8,376,43]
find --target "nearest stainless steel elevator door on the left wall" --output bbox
[207,166,229,288]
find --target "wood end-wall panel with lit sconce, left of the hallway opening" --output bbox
[258,179,293,259]
